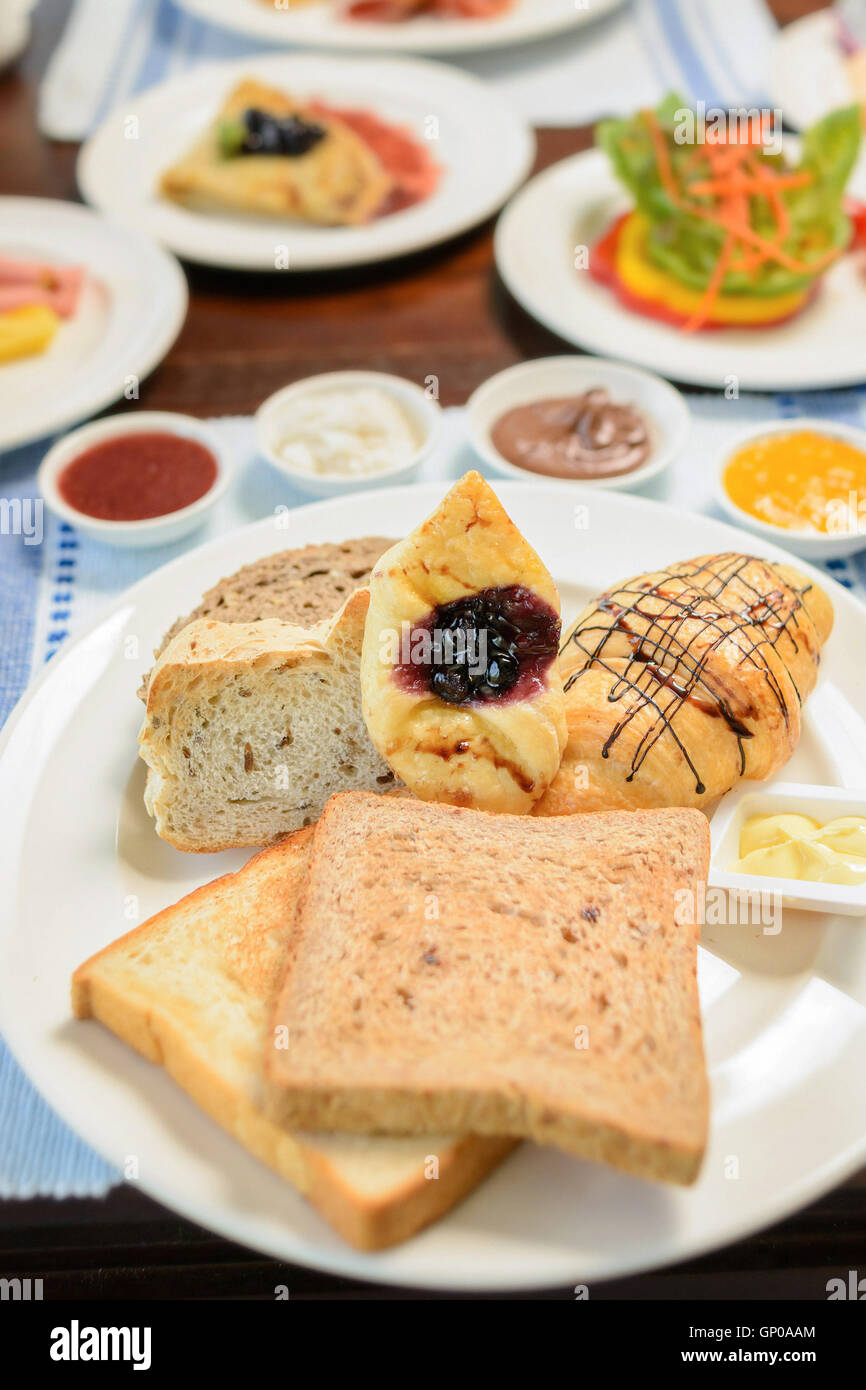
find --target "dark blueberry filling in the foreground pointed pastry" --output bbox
[395,584,560,705]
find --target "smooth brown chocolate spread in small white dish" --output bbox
[491,386,652,480]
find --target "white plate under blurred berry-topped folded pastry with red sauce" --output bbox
[78,54,535,272]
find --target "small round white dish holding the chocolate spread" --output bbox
[467,356,691,491]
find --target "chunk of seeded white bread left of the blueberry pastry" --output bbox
[139,589,395,853]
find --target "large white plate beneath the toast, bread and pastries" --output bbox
[0,482,866,1290]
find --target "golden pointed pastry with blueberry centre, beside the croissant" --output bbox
[361,473,566,813]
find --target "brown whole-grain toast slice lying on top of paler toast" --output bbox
[265,794,709,1183]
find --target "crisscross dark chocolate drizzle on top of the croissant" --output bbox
[563,555,810,795]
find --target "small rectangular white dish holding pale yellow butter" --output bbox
[709,781,866,917]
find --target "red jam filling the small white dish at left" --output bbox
[57,431,217,521]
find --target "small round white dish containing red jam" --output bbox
[36,410,231,549]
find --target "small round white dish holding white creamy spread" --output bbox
[256,371,442,498]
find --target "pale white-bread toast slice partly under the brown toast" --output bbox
[72,830,512,1250]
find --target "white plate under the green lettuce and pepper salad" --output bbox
[496,150,866,391]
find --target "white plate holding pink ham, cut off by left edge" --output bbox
[0,197,186,452]
